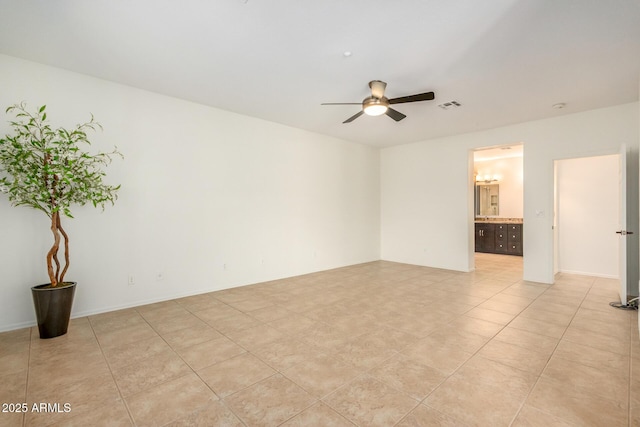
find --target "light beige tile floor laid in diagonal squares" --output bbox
[0,254,640,427]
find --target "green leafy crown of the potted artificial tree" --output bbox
[0,103,122,217]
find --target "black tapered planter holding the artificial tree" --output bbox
[31,282,76,338]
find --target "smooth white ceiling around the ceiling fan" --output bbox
[0,0,640,146]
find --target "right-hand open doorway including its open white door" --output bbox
[554,150,639,305]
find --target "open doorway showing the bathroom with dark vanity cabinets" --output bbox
[470,143,524,267]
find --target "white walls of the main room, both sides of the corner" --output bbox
[0,55,640,330]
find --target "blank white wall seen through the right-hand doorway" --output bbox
[556,155,620,278]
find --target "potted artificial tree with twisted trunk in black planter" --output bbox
[0,103,122,338]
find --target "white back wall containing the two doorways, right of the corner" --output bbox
[381,102,638,283]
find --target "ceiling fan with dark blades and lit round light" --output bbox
[322,80,435,123]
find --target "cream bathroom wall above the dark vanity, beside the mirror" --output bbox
[474,157,524,218]
